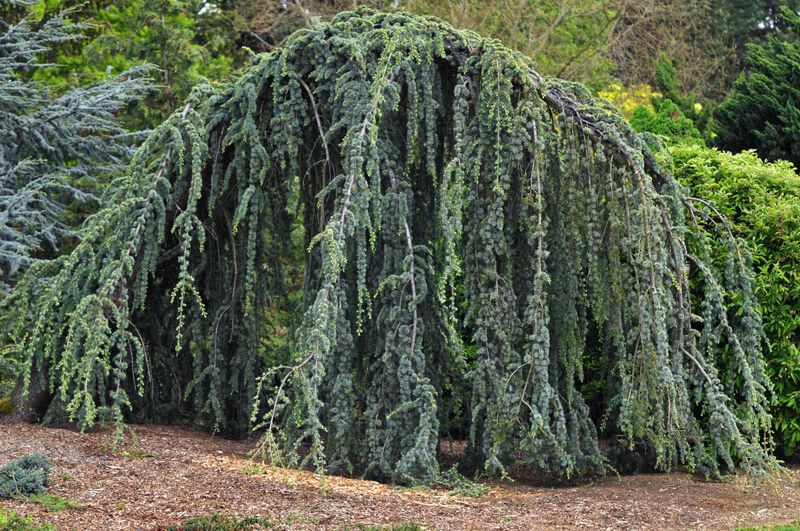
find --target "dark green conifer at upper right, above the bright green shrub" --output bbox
[714,8,800,164]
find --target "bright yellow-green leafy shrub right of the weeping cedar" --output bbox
[671,145,800,456]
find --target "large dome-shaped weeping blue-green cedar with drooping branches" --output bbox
[4,10,774,482]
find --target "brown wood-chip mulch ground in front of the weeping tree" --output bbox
[0,424,800,530]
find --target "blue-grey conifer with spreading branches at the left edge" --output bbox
[0,2,149,283]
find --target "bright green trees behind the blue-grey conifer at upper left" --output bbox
[18,0,236,128]
